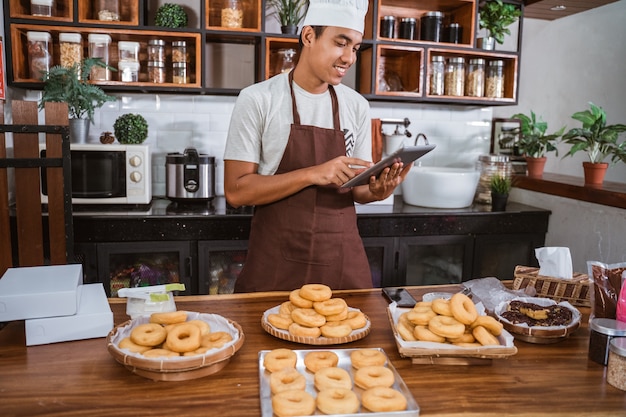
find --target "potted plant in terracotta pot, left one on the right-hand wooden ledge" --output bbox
[512,110,565,178]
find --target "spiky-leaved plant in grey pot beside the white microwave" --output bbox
[39,58,117,143]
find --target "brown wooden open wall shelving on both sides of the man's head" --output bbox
[3,0,523,106]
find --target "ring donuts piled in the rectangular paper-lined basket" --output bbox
[396,293,503,347]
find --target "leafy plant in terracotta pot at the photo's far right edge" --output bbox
[563,102,626,186]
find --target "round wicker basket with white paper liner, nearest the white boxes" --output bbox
[107,312,245,381]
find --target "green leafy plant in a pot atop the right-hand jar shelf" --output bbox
[478,0,522,50]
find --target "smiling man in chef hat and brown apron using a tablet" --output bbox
[224,0,409,292]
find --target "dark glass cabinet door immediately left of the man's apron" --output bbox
[198,240,248,294]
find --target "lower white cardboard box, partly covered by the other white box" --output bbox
[25,283,113,346]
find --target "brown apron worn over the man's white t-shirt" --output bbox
[235,71,372,292]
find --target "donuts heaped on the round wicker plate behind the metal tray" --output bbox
[267,284,367,338]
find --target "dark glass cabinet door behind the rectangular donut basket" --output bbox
[390,236,473,286]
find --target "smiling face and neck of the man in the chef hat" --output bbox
[294,26,363,94]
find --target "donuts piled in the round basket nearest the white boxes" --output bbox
[118,311,233,358]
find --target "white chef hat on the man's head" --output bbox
[302,0,368,34]
